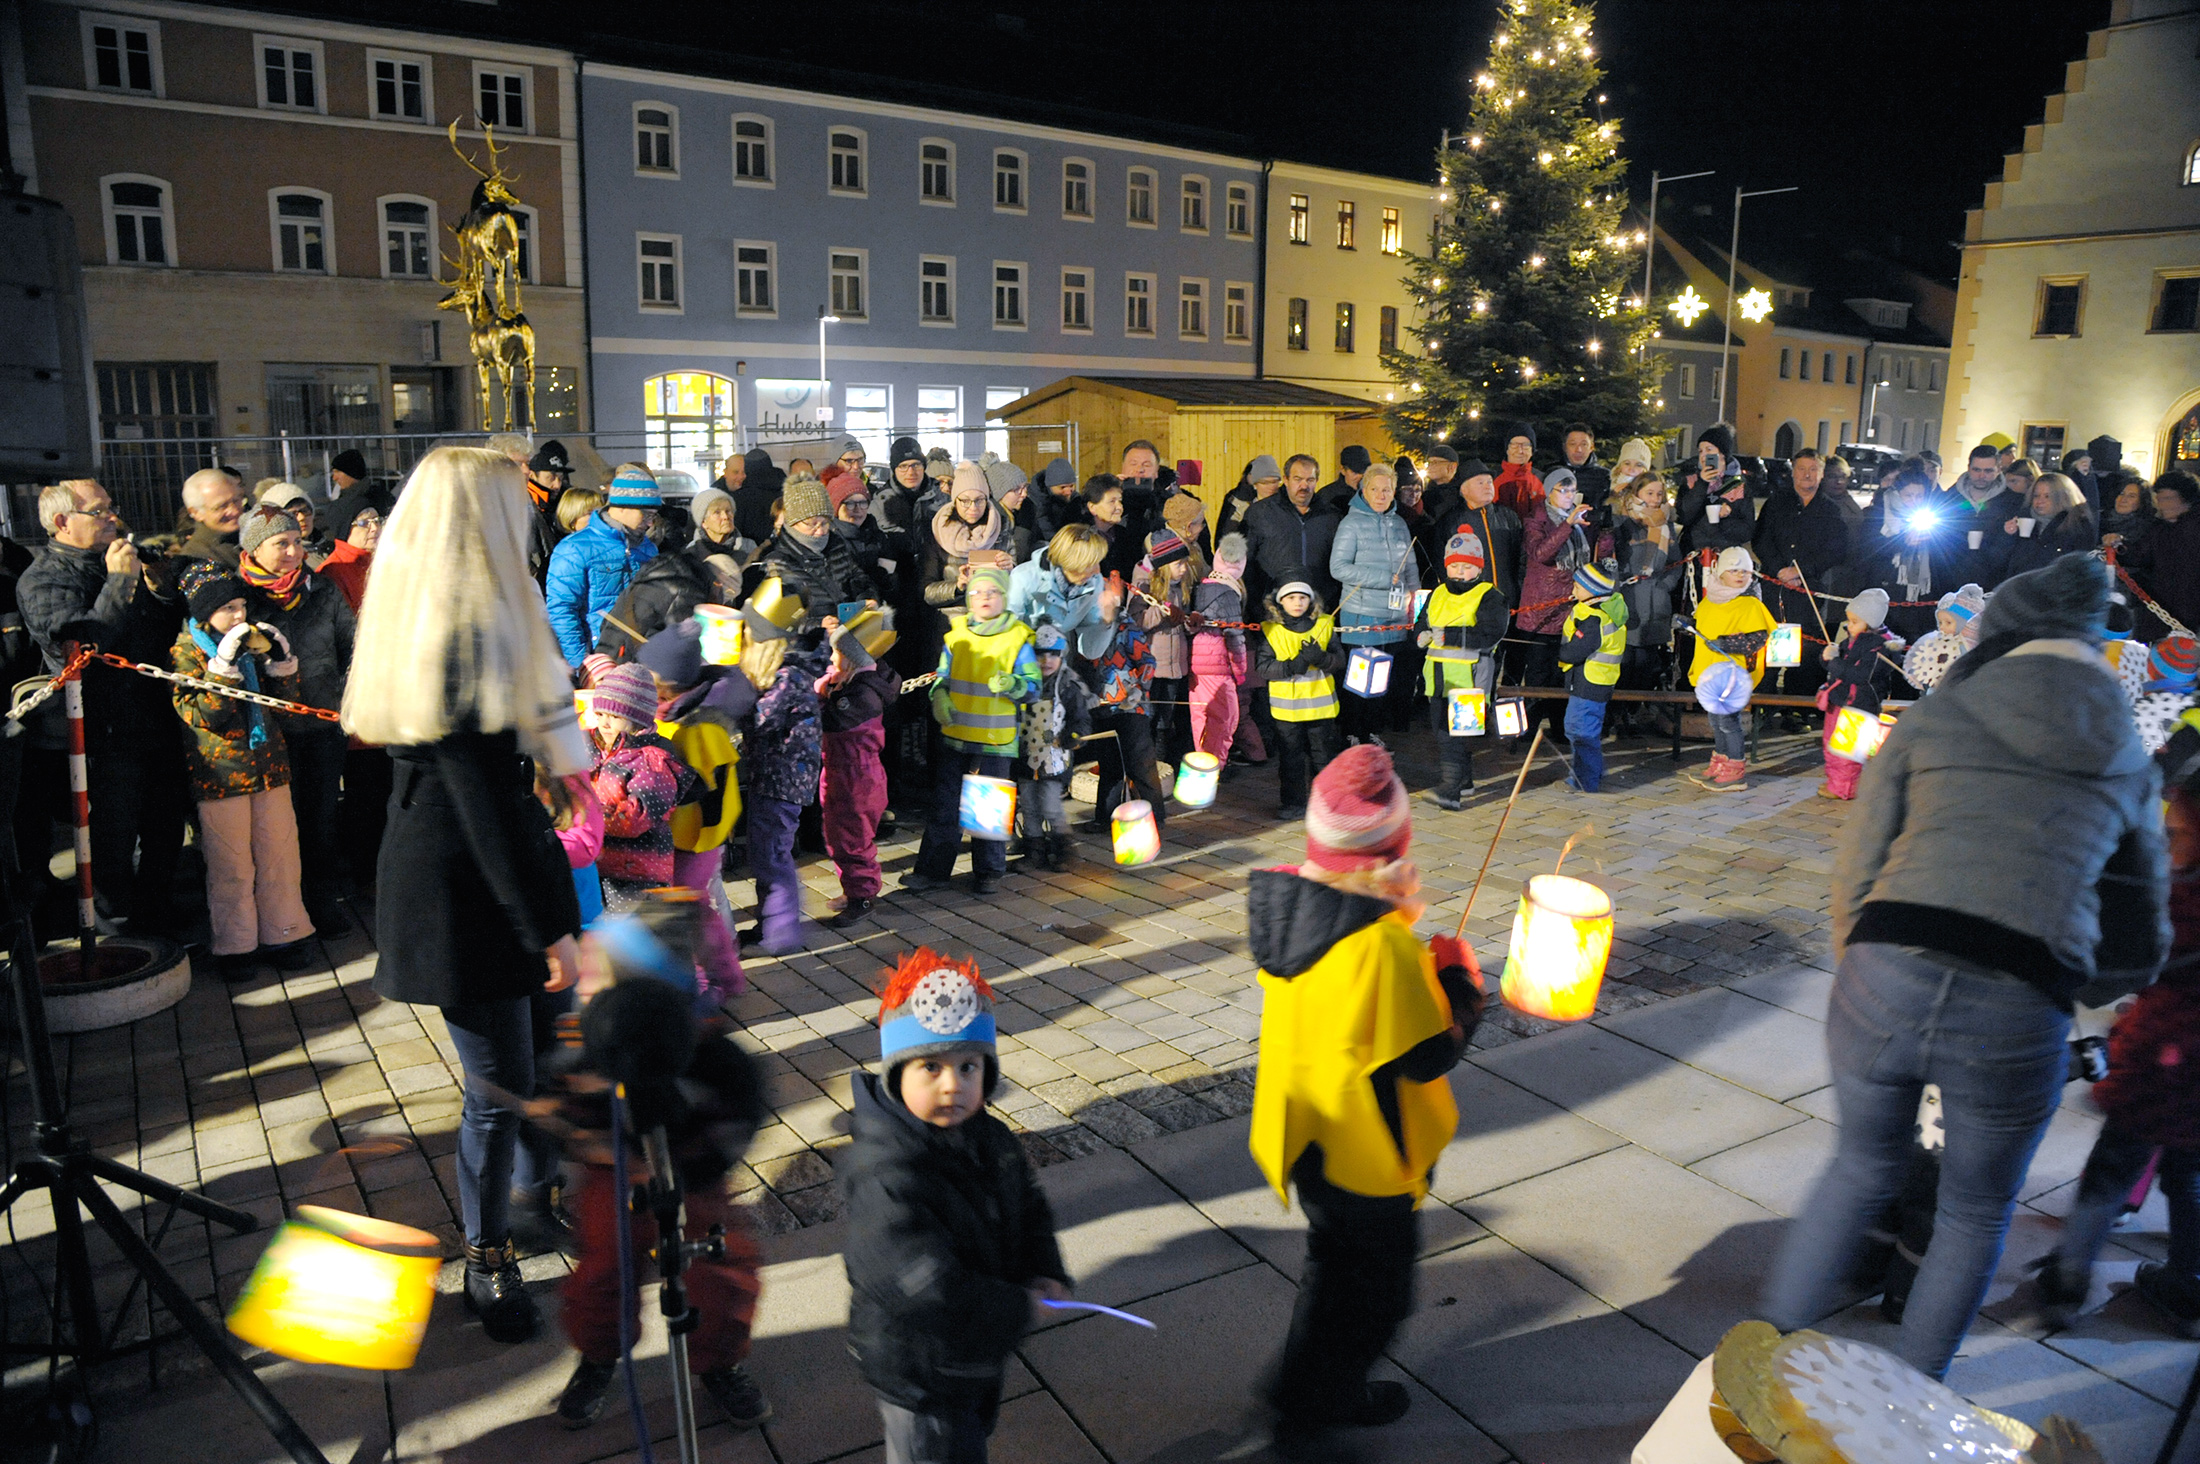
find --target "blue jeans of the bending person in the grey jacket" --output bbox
[1764,944,2070,1378]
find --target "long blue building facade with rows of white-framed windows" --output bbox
[581,66,1263,478]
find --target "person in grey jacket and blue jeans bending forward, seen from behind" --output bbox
[1764,555,2169,1378]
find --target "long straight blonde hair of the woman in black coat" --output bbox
[343,447,590,777]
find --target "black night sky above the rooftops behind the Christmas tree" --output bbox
[684,0,2110,280]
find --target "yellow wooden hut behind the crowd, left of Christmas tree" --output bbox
[986,376,1395,522]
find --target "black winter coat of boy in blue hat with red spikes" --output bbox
[840,1069,1069,1413]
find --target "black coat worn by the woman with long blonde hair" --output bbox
[374,731,581,1006]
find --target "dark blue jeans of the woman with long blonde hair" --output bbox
[442,991,574,1246]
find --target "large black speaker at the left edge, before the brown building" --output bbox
[0,194,99,482]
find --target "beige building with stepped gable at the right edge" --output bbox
[1949,0,2200,478]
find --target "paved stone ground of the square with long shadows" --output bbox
[0,735,2200,1464]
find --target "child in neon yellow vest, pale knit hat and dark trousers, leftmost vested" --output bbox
[902,566,1038,894]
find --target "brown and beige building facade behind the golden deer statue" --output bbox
[0,0,587,512]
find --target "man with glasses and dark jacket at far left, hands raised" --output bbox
[15,479,190,936]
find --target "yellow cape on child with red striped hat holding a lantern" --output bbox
[1250,909,1459,1204]
